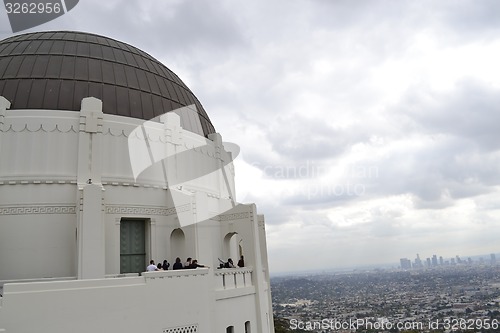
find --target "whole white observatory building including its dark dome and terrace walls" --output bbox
[0,31,274,333]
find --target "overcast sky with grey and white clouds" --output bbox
[0,0,500,273]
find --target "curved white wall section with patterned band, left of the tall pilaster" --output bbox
[0,184,76,280]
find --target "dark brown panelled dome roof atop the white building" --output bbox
[0,31,215,137]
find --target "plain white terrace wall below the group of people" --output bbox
[0,269,212,333]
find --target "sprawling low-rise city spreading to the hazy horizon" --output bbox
[271,265,500,332]
